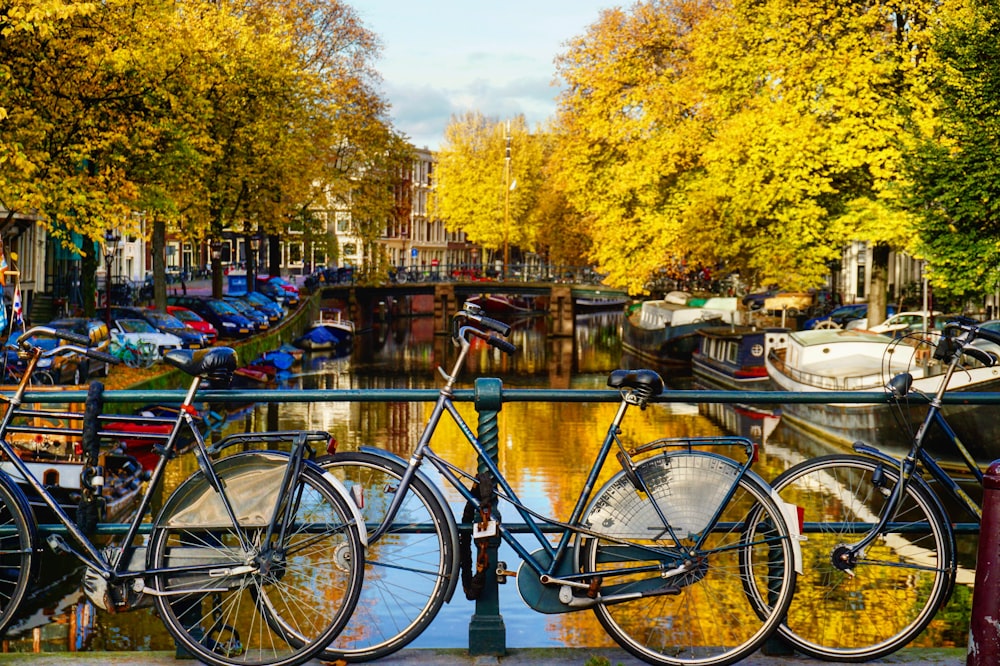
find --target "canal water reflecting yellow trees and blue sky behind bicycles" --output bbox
[3,313,975,651]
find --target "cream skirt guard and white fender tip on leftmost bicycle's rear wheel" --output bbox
[157,451,368,546]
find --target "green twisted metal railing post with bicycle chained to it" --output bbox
[469,378,507,656]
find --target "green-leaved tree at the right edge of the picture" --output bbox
[907,2,1000,304]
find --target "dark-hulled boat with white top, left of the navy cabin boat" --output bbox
[622,292,740,366]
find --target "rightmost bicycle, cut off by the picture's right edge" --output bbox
[772,319,1000,662]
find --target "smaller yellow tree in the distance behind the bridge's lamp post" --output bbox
[432,112,544,272]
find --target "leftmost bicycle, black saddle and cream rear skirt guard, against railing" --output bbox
[0,326,366,666]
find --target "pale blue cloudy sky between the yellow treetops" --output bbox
[350,0,623,150]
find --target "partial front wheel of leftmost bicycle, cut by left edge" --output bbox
[0,475,38,632]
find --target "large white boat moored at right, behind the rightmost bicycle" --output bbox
[765,329,1000,462]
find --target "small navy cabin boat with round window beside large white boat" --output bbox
[691,324,770,391]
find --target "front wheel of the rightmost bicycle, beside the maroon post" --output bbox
[756,454,957,662]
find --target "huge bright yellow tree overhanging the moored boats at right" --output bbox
[557,0,936,312]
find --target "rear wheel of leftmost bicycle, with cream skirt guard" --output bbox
[149,451,364,666]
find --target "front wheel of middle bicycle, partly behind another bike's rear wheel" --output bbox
[317,451,458,662]
